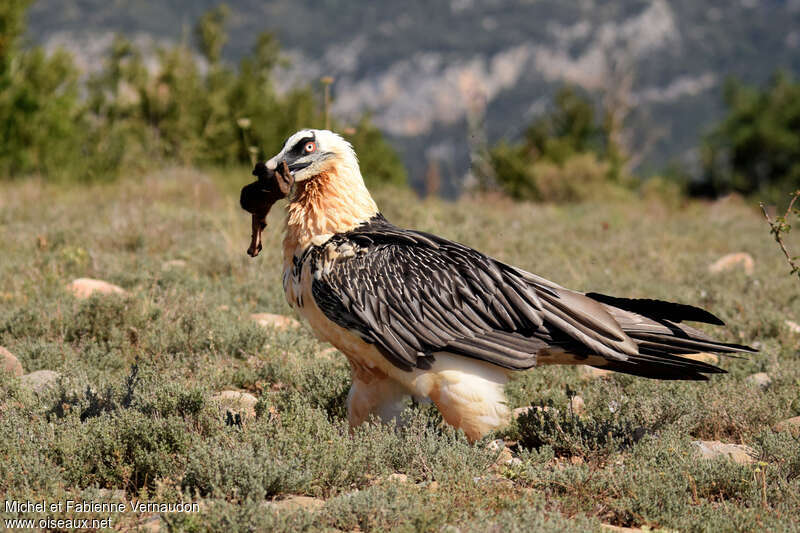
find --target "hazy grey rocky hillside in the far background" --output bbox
[29,0,800,188]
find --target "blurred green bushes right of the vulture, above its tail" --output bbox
[491,76,800,202]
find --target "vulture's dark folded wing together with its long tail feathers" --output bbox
[310,215,748,379]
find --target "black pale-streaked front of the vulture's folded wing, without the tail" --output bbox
[311,216,547,369]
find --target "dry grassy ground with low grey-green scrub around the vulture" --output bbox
[0,169,800,531]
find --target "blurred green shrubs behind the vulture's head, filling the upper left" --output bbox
[0,0,406,185]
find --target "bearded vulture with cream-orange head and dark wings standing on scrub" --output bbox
[242,129,754,441]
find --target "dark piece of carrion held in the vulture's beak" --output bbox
[244,161,294,257]
